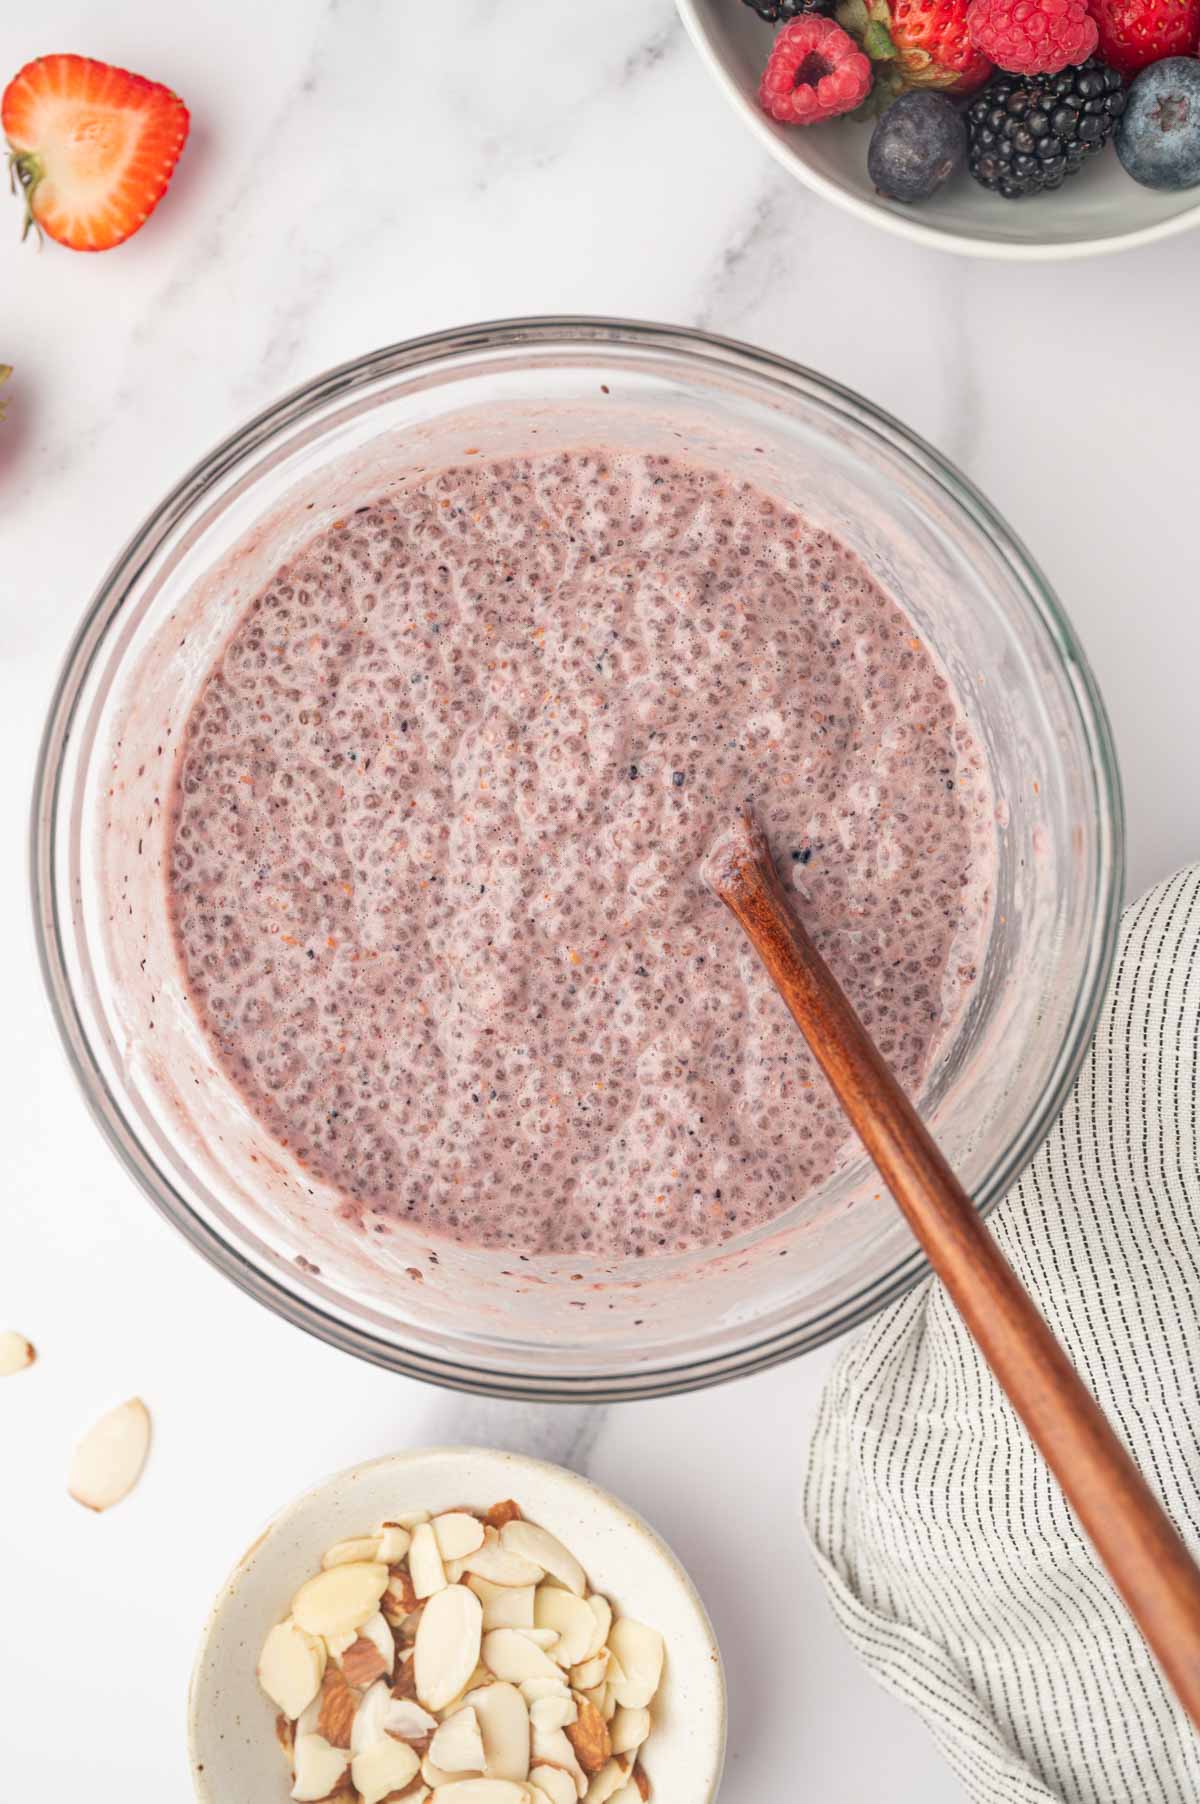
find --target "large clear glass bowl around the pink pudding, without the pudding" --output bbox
[32,319,1122,1400]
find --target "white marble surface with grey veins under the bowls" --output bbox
[0,0,1200,1804]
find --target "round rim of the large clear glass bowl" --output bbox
[29,314,1124,1402]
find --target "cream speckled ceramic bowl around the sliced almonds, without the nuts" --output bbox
[188,1447,725,1804]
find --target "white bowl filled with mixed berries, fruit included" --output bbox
[677,0,1200,258]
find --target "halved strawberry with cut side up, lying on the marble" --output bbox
[0,56,188,251]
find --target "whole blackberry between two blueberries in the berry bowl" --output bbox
[967,56,1126,200]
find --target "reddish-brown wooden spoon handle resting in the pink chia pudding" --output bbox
[706,815,1200,1728]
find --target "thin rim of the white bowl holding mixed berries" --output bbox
[675,0,1200,263]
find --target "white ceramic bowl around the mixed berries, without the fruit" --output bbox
[675,0,1200,262]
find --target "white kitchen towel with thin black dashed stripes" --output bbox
[805,866,1200,1804]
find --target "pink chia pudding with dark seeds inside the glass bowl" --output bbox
[170,449,996,1259]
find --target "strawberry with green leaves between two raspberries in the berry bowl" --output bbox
[835,0,992,105]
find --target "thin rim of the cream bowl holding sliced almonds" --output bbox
[188,1445,729,1804]
